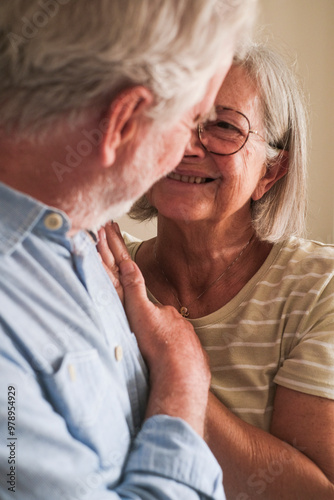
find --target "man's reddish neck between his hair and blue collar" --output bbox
[0,129,98,232]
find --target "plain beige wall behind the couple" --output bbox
[119,0,334,243]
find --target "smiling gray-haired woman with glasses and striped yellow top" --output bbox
[100,45,334,500]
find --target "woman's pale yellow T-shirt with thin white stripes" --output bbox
[124,234,334,431]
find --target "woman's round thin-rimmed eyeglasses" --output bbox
[197,107,265,156]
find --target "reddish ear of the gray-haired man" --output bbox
[101,86,153,167]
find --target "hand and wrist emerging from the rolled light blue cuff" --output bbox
[98,223,210,436]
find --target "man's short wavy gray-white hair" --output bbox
[0,0,257,135]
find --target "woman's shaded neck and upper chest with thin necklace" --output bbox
[137,214,271,317]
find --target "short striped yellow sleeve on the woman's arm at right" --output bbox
[274,278,334,399]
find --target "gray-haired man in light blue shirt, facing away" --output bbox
[0,0,255,500]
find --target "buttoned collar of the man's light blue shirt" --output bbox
[0,183,71,254]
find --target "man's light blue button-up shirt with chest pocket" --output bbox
[0,184,225,500]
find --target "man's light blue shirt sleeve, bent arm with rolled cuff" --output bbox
[0,329,225,500]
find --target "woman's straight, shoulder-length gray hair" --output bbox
[129,43,307,243]
